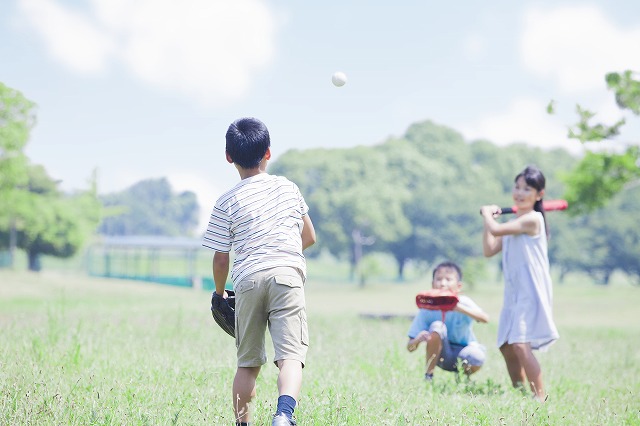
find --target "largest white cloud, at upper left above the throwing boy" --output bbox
[19,0,278,104]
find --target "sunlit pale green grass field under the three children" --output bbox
[0,271,640,425]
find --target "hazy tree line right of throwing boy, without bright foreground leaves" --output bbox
[271,121,640,283]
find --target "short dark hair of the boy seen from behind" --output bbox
[226,117,271,169]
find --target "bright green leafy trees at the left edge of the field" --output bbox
[0,83,100,270]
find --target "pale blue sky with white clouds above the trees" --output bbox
[0,0,640,230]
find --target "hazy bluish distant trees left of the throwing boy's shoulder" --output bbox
[99,178,199,236]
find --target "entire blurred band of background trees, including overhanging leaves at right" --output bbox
[0,73,640,283]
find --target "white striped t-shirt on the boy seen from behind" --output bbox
[202,173,309,284]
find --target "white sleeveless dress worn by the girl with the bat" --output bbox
[498,211,559,351]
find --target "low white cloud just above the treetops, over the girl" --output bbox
[458,98,582,153]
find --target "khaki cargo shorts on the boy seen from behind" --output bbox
[234,267,309,367]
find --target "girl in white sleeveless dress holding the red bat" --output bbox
[481,166,559,401]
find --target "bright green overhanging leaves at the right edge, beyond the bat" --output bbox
[564,71,640,214]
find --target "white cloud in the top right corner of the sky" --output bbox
[520,6,640,93]
